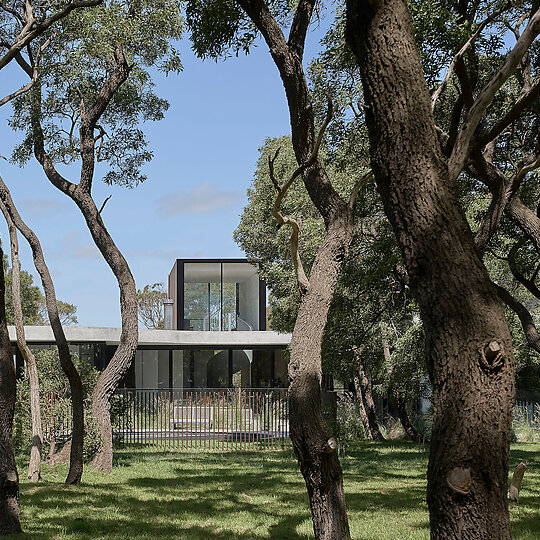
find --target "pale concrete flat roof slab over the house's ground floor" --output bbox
[8,326,291,349]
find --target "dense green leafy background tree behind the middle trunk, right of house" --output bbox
[234,137,425,440]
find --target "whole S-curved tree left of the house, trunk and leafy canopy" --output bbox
[11,0,181,472]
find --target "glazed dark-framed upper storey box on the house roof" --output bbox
[165,259,266,332]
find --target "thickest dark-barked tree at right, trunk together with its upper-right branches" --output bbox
[347,0,540,539]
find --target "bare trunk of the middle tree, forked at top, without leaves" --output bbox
[237,0,357,540]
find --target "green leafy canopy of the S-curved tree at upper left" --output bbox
[10,0,182,187]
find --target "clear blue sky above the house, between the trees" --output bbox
[0,16,326,326]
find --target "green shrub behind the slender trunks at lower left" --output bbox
[13,349,99,460]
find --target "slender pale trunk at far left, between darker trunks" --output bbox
[0,207,43,482]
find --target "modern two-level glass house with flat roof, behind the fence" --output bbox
[9,259,290,389]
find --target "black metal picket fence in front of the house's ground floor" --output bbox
[112,388,290,450]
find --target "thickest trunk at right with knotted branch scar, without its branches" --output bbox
[347,0,514,540]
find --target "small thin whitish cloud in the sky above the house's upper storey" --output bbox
[157,182,242,216]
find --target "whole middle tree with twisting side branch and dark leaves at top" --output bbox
[186,0,374,539]
